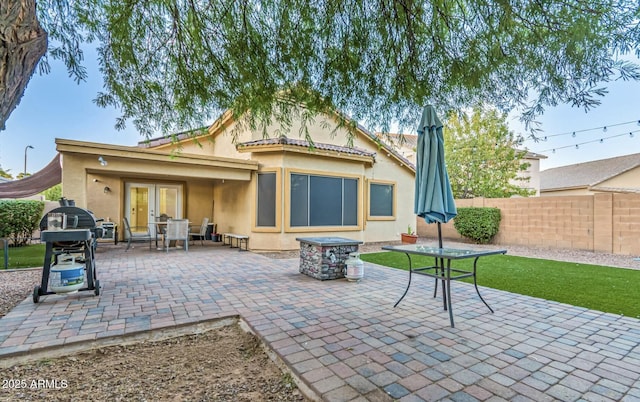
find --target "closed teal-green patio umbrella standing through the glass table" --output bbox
[414,105,457,248]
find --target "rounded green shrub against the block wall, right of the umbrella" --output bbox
[453,207,502,244]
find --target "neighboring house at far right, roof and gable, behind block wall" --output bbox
[540,153,640,196]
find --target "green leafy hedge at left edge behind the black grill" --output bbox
[0,200,44,246]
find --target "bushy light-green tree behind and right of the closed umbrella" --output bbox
[443,107,535,198]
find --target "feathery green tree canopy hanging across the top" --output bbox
[0,0,640,138]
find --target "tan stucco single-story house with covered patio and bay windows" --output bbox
[56,108,415,250]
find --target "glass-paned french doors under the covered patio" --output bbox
[125,183,182,236]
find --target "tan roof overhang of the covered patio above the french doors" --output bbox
[56,138,258,181]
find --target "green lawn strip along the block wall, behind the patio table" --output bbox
[360,252,640,318]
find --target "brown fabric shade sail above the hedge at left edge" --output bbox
[0,154,62,198]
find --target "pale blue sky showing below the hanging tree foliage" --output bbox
[0,49,640,177]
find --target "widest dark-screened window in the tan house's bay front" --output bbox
[290,173,358,227]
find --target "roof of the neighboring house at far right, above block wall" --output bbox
[540,153,640,192]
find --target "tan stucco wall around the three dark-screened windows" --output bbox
[192,114,415,250]
